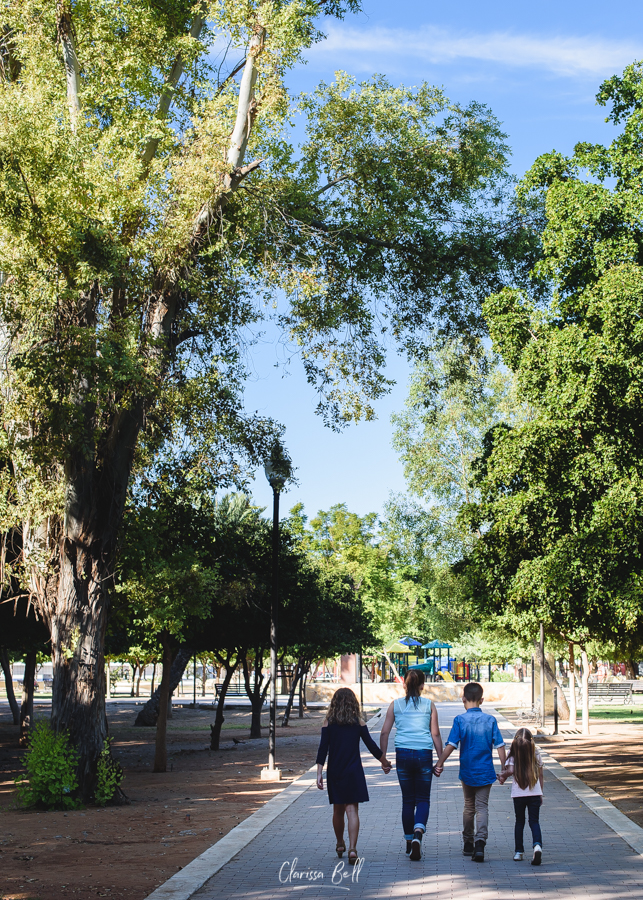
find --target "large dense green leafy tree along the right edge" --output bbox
[458,64,643,724]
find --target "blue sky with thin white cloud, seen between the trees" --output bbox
[246,0,643,514]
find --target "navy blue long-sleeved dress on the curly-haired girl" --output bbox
[317,722,383,803]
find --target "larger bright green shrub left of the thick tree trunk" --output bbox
[16,722,79,809]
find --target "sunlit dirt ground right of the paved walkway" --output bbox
[504,710,643,827]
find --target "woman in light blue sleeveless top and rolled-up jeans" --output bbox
[380,669,442,860]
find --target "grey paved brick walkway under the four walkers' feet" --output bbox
[189,704,643,900]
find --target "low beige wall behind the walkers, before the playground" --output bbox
[306,681,531,707]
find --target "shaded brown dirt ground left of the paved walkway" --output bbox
[0,703,344,900]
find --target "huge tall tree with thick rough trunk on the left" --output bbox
[0,0,532,794]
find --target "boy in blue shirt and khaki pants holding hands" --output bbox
[434,682,507,862]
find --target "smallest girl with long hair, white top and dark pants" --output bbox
[498,728,543,866]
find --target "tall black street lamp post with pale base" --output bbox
[261,442,292,781]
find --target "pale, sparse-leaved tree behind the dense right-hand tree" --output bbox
[383,341,529,648]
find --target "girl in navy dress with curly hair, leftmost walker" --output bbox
[317,688,391,866]
